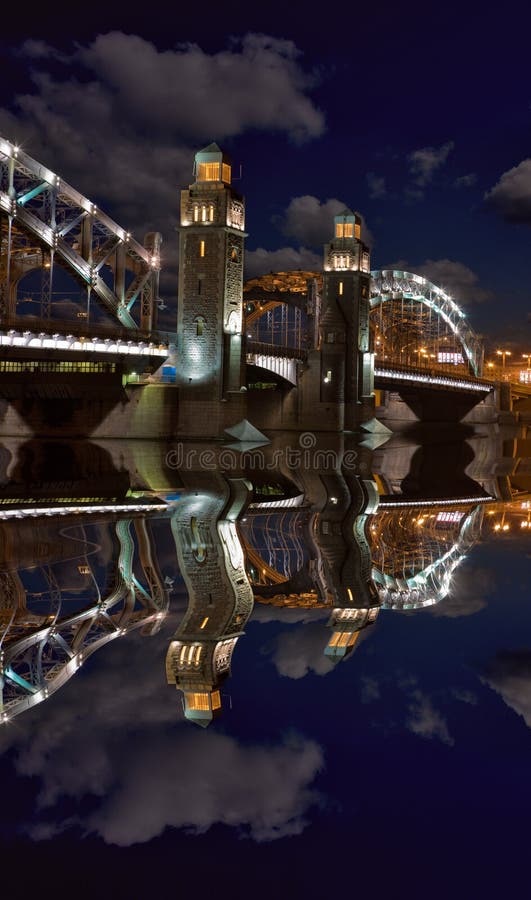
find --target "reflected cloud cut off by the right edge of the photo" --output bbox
[482,650,531,728]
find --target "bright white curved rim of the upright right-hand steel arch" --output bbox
[371,269,483,375]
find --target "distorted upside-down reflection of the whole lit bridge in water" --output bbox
[0,435,531,726]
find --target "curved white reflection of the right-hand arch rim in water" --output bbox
[372,505,483,610]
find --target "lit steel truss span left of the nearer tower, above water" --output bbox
[0,138,161,331]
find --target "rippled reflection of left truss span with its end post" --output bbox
[0,510,168,722]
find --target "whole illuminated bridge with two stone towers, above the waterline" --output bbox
[0,139,529,436]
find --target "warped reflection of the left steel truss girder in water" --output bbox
[0,520,168,723]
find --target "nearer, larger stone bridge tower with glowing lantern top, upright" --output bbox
[177,144,246,400]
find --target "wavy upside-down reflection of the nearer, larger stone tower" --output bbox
[166,479,253,727]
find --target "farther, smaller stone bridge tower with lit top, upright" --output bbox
[321,209,374,431]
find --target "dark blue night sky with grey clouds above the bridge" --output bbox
[0,2,531,353]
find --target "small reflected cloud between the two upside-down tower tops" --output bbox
[264,624,334,678]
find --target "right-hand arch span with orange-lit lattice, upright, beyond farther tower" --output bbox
[371,269,483,375]
